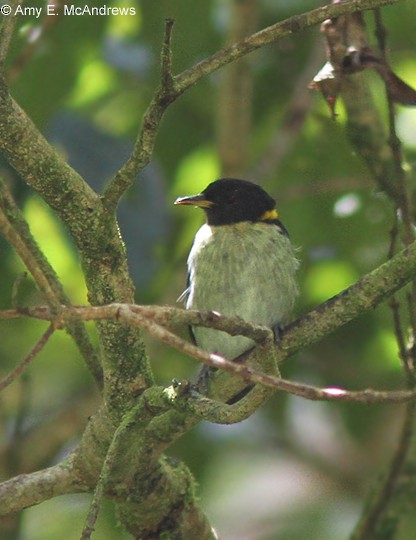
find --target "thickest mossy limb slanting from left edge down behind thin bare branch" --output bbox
[0,79,153,421]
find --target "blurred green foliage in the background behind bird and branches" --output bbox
[0,0,416,540]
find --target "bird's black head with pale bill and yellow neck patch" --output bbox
[175,178,277,225]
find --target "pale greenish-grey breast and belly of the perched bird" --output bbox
[186,223,298,358]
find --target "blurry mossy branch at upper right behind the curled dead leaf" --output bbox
[312,6,407,204]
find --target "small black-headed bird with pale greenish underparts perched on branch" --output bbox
[175,178,298,359]
